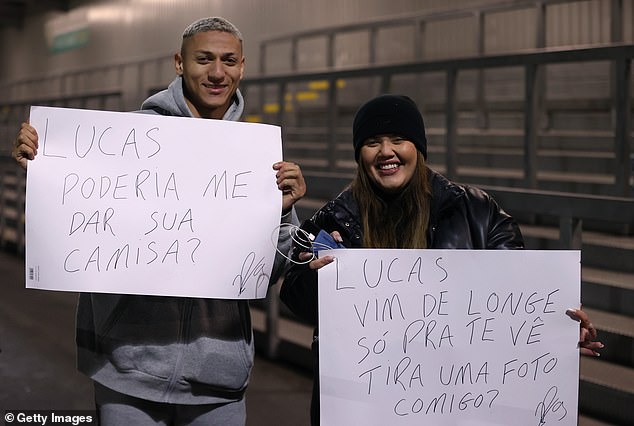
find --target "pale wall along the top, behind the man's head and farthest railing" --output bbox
[0,0,634,109]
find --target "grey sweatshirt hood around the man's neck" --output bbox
[141,76,244,121]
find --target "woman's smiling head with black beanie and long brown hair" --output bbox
[351,95,431,248]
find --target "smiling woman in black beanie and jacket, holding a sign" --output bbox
[280,95,598,425]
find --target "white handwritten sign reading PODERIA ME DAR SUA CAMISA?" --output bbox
[26,107,282,299]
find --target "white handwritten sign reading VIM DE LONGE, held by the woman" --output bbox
[319,250,580,426]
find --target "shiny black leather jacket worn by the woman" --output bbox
[280,170,524,325]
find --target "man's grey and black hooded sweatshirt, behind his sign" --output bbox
[76,77,299,404]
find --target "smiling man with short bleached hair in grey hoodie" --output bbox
[13,17,306,426]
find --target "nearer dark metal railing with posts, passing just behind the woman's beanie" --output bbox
[242,45,634,197]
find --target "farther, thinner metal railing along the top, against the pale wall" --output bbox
[259,0,631,135]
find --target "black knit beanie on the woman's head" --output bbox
[352,95,427,162]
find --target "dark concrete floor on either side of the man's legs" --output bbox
[0,251,311,426]
